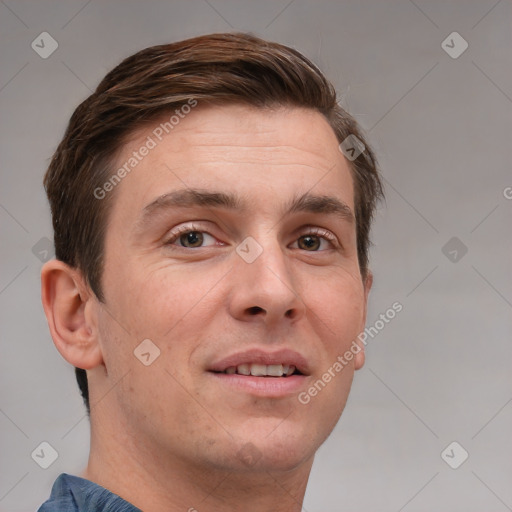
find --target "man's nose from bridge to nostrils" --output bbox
[229,237,306,326]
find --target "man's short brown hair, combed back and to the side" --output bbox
[44,34,383,411]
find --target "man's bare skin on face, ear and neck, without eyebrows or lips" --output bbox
[42,105,371,512]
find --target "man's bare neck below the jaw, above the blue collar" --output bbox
[81,402,313,512]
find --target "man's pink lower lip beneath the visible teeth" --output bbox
[210,372,306,398]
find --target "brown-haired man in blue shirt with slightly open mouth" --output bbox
[40,34,382,512]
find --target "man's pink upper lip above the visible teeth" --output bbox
[209,348,309,375]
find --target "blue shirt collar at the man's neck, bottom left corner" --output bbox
[37,473,142,512]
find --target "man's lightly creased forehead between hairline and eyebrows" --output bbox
[110,105,353,221]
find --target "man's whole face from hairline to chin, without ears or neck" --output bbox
[90,105,368,471]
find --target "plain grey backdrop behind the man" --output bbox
[0,0,512,512]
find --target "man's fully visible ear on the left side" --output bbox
[41,260,103,370]
